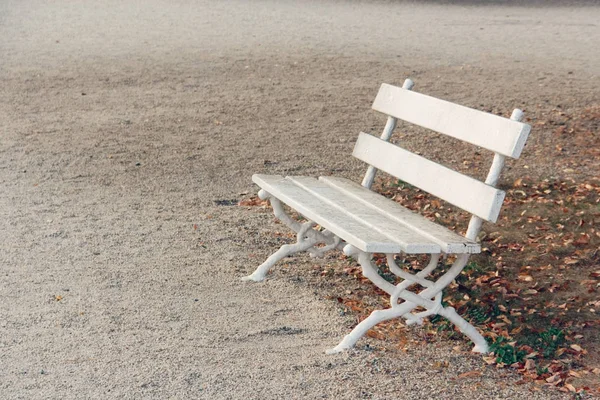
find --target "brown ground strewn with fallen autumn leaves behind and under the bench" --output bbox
[238,105,600,398]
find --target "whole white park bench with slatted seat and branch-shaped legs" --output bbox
[243,79,531,353]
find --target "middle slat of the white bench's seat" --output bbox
[286,176,441,254]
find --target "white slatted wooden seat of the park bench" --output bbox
[252,174,481,254]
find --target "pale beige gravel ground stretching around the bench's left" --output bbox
[0,0,600,399]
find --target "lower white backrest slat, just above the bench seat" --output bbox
[352,132,505,222]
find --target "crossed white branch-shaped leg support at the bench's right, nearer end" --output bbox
[327,245,488,354]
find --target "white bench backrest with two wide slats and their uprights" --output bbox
[353,79,531,239]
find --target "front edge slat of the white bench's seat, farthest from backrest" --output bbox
[252,174,402,253]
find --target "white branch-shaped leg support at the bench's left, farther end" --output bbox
[242,190,344,282]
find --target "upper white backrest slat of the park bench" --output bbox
[373,83,531,158]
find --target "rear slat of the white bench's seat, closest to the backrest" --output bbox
[319,176,481,254]
